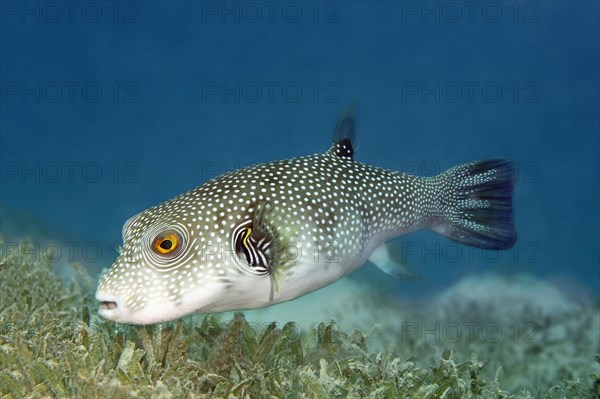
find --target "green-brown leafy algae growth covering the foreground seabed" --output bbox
[0,240,600,399]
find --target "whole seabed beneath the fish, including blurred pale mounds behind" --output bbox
[0,242,600,399]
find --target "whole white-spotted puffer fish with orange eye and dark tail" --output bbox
[96,109,516,324]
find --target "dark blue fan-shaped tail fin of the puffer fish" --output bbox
[434,159,517,249]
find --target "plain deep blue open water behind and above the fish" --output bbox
[0,1,600,295]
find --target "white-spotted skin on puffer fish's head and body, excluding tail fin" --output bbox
[99,145,434,310]
